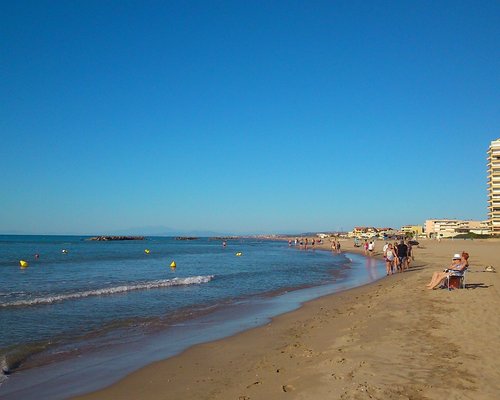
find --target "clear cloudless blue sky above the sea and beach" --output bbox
[0,0,500,234]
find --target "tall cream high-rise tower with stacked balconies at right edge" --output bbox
[487,139,500,235]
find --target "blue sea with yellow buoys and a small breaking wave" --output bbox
[0,235,385,400]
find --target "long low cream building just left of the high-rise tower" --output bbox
[425,219,489,239]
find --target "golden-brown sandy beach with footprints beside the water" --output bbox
[78,240,500,400]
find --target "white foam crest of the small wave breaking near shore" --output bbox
[0,275,214,307]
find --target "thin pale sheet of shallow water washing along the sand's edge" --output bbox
[3,245,383,398]
